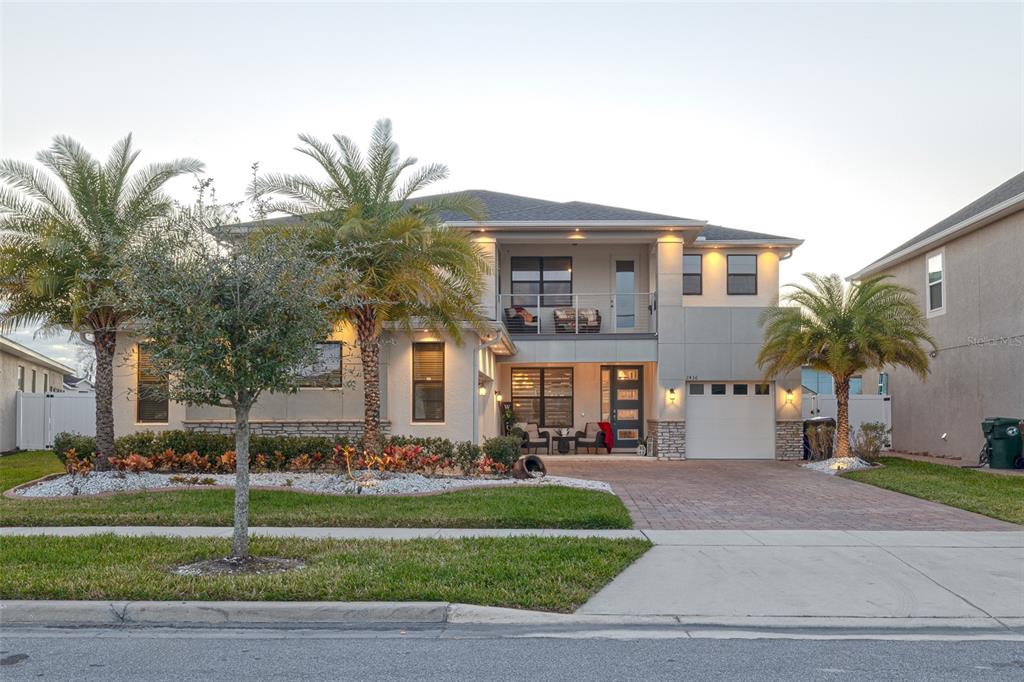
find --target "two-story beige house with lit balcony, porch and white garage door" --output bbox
[115,190,802,459]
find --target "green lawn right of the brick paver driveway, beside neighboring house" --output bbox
[843,457,1024,524]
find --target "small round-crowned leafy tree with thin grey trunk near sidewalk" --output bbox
[125,197,331,560]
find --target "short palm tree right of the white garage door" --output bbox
[758,273,936,457]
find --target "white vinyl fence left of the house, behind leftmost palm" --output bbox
[15,392,96,450]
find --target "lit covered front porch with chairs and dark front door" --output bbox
[497,361,656,456]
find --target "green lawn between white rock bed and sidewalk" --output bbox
[0,452,633,528]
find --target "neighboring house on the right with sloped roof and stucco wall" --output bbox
[849,173,1024,459]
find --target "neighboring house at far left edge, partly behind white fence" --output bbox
[0,336,73,453]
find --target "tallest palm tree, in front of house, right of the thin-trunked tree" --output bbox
[251,119,487,450]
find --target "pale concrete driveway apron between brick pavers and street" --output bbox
[578,530,1024,626]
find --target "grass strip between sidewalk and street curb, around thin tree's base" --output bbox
[0,535,650,611]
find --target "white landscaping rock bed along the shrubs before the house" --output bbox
[16,471,611,498]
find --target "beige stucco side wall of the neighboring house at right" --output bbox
[864,212,1024,459]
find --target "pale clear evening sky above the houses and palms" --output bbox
[0,2,1024,363]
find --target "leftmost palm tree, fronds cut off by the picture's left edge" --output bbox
[0,135,203,470]
